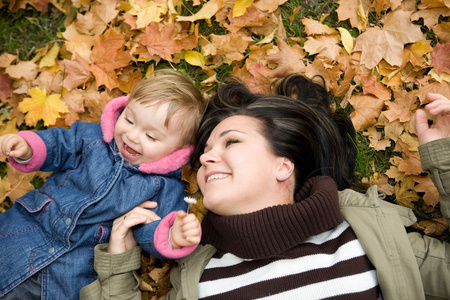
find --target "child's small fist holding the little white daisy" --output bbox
[170,210,201,249]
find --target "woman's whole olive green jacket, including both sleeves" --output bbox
[80,138,450,300]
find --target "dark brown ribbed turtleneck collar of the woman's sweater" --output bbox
[202,176,343,259]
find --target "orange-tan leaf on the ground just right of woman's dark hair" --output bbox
[348,94,384,130]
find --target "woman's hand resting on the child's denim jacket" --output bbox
[108,201,161,254]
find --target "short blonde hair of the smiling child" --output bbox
[128,69,207,146]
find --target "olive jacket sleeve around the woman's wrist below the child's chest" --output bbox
[80,244,142,300]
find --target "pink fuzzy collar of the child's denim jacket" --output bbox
[100,96,194,174]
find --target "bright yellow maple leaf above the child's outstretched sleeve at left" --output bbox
[18,87,69,126]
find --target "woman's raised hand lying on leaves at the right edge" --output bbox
[416,93,450,145]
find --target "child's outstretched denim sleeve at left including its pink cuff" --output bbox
[9,122,101,173]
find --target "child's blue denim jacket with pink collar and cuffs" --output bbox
[0,97,192,299]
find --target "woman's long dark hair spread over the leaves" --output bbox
[191,75,356,190]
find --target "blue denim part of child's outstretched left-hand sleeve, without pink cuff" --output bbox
[35,122,102,172]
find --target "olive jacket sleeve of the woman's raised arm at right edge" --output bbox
[408,138,450,299]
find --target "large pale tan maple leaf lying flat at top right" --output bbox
[354,10,423,69]
